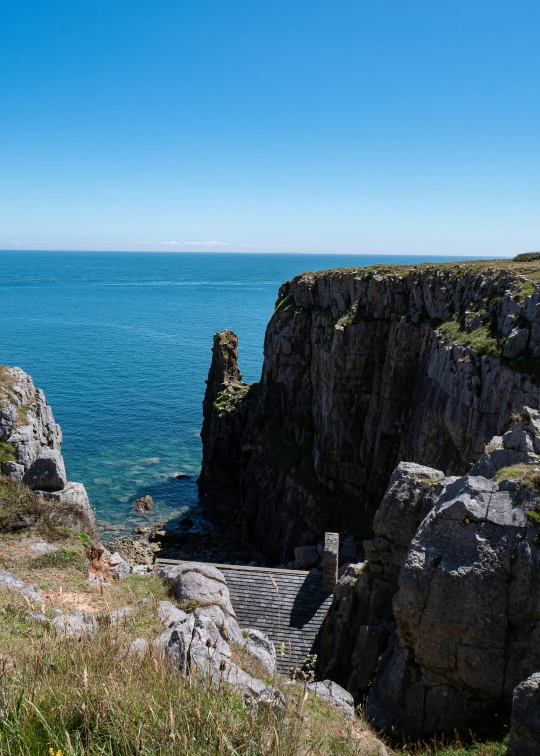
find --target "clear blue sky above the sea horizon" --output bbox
[0,0,540,255]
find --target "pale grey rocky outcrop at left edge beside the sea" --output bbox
[0,366,94,527]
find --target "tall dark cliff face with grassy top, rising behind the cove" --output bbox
[200,262,540,562]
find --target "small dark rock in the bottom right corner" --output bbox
[508,672,540,756]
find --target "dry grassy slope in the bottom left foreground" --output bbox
[0,578,386,756]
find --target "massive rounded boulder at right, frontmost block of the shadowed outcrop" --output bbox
[367,476,540,735]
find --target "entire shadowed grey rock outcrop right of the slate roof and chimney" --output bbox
[322,414,540,736]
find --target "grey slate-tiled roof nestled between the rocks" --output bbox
[157,559,332,672]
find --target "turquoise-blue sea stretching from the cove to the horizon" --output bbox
[0,252,490,526]
